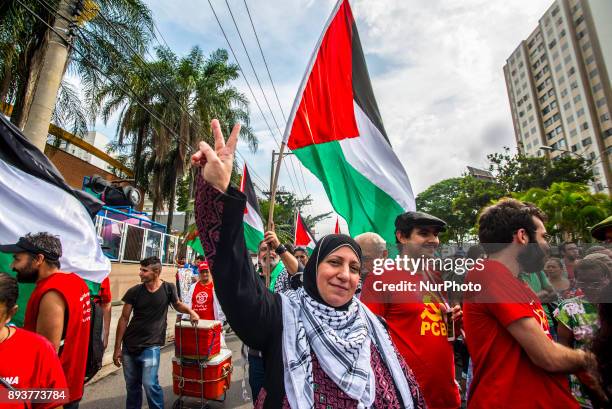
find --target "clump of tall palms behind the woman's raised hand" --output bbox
[92,47,257,228]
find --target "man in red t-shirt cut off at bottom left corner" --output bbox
[0,273,68,409]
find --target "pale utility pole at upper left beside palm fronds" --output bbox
[23,0,75,152]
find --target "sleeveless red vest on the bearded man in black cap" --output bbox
[23,272,91,402]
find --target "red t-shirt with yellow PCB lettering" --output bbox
[360,270,461,409]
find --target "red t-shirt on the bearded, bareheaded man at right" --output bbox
[463,260,579,409]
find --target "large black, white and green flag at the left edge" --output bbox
[0,115,111,325]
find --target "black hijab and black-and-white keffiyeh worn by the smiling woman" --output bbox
[281,234,413,409]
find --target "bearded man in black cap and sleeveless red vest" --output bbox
[0,233,91,409]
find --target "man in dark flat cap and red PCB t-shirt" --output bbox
[361,212,461,409]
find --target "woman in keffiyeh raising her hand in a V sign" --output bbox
[191,120,425,409]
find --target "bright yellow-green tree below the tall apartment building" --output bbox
[514,182,612,242]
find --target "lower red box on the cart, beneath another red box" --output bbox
[172,349,233,399]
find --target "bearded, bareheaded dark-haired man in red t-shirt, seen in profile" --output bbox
[464,199,595,409]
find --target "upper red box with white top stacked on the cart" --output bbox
[174,320,221,359]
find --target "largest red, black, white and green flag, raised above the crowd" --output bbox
[284,0,415,242]
